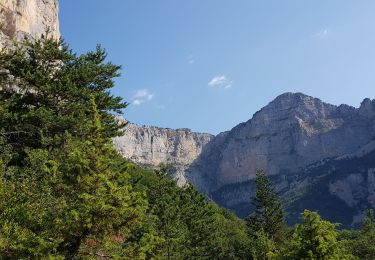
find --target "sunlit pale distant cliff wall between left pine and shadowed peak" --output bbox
[114,124,213,185]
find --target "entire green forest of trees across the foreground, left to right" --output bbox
[0,36,375,259]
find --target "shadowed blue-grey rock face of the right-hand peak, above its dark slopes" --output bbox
[187,93,375,193]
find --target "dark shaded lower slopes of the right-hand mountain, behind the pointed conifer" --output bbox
[208,138,375,228]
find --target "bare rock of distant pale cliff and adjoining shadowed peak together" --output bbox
[115,93,375,194]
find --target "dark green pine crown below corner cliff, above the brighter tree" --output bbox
[0,34,127,155]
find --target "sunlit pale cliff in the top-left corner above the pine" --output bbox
[0,0,60,47]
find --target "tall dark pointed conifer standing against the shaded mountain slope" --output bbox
[247,171,285,242]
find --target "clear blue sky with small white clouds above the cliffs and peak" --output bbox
[60,0,375,134]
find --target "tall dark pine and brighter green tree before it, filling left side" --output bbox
[0,37,147,259]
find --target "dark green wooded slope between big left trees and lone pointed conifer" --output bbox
[125,170,250,259]
